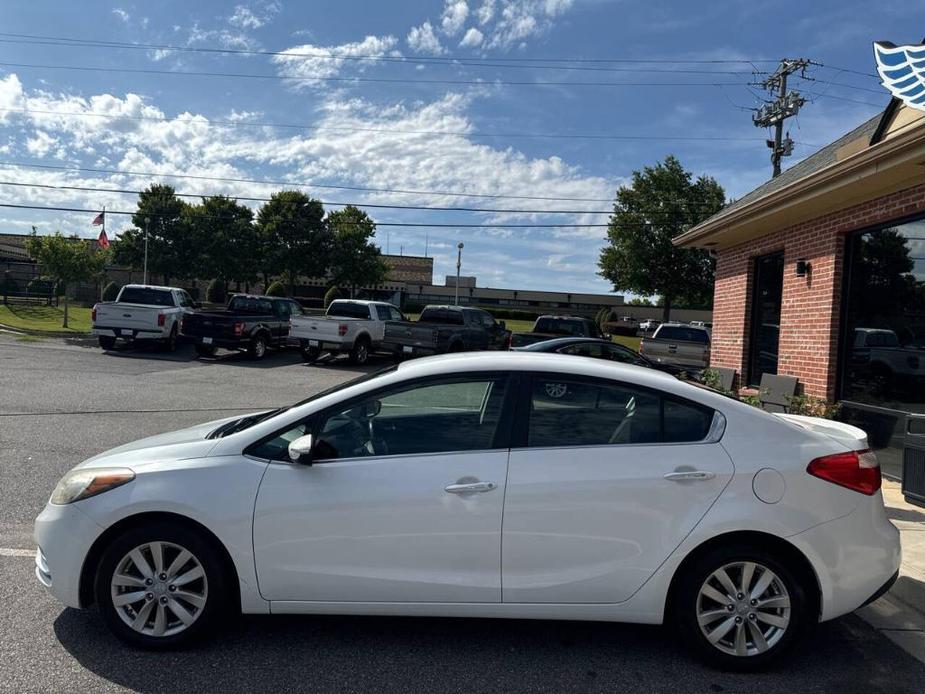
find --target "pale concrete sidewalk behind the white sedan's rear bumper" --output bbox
[858,479,925,663]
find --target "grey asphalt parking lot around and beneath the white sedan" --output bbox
[0,336,925,693]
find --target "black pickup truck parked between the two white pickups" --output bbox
[181,294,303,359]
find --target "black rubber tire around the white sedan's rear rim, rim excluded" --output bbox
[671,545,816,672]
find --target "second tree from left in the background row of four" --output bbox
[184,195,258,291]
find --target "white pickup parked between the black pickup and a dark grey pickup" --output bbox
[290,299,407,364]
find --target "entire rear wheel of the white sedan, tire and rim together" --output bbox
[674,545,812,671]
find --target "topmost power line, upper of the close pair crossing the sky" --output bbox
[0,32,777,65]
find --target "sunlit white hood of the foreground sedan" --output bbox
[76,413,255,468]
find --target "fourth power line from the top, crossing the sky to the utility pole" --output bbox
[0,108,818,147]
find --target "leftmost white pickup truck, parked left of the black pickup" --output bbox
[91,284,196,352]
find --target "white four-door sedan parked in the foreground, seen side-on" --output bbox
[35,353,900,669]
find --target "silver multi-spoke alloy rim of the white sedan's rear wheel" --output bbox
[697,561,790,657]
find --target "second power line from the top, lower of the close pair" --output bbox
[0,33,761,75]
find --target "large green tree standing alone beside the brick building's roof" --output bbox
[598,156,725,321]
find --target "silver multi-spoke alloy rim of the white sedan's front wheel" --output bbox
[110,542,209,638]
